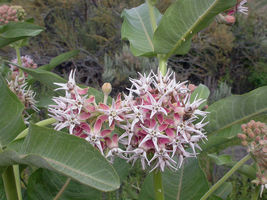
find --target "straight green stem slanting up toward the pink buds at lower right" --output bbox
[200,154,251,200]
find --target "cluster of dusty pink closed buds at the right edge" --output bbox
[238,120,267,197]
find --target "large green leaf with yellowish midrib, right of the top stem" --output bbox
[153,0,236,58]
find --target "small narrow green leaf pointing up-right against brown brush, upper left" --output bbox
[39,50,80,71]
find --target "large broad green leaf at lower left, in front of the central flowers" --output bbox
[0,124,120,191]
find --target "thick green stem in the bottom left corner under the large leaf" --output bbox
[2,166,19,200]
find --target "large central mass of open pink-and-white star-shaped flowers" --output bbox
[49,71,208,171]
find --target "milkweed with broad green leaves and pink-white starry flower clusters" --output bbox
[0,0,267,200]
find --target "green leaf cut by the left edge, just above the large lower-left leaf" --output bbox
[0,75,25,149]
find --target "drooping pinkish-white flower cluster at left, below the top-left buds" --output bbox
[7,56,39,124]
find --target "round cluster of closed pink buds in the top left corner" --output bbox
[0,5,26,25]
